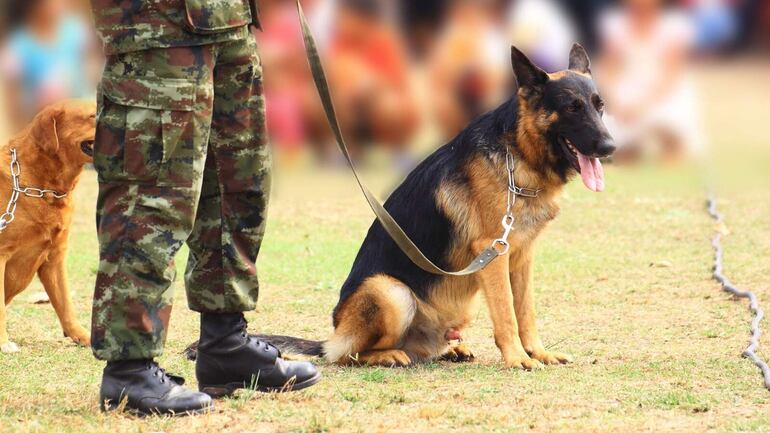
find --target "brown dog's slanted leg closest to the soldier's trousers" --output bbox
[37,250,91,346]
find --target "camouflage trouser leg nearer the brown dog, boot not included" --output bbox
[92,45,216,361]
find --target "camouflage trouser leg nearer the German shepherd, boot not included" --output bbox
[185,38,271,313]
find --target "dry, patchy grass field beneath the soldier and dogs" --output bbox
[0,64,770,433]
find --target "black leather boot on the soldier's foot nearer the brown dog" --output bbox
[99,359,212,415]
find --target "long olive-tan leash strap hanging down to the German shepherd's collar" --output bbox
[297,0,498,276]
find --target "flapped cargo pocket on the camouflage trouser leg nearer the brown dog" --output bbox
[94,76,208,187]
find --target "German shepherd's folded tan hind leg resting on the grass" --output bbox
[324,275,417,367]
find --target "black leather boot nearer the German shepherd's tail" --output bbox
[195,313,321,398]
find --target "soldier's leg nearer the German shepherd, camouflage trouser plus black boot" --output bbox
[185,39,321,397]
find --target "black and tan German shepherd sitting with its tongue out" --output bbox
[184,44,615,369]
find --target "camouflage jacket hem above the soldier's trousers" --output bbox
[91,0,252,55]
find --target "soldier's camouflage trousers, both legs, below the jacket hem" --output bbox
[92,37,271,360]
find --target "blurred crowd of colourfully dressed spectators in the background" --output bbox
[0,0,770,168]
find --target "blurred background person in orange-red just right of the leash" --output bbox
[318,0,419,168]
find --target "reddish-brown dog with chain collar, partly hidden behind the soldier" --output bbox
[0,101,96,352]
